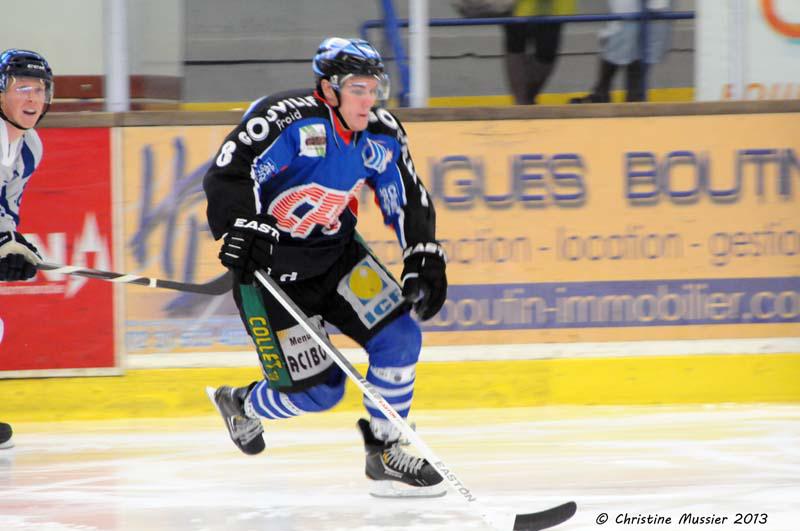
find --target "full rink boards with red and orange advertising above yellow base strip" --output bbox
[0,101,800,416]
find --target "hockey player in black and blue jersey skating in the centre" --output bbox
[204,38,447,496]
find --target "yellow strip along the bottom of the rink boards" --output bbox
[0,354,800,422]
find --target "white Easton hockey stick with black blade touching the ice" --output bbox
[255,270,577,531]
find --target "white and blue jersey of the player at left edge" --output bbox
[0,119,43,232]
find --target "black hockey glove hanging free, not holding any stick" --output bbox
[400,242,447,321]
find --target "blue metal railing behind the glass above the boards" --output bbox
[359,6,694,107]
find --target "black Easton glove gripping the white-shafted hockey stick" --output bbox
[219,215,280,284]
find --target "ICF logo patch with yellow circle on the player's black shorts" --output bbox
[336,255,403,328]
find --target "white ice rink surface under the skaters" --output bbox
[0,405,800,531]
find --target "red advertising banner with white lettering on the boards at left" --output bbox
[0,129,116,377]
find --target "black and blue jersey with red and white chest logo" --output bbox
[203,91,435,278]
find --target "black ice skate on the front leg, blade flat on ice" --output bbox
[358,419,447,498]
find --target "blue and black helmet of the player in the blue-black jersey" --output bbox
[312,37,389,100]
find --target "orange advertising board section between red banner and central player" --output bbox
[120,126,238,354]
